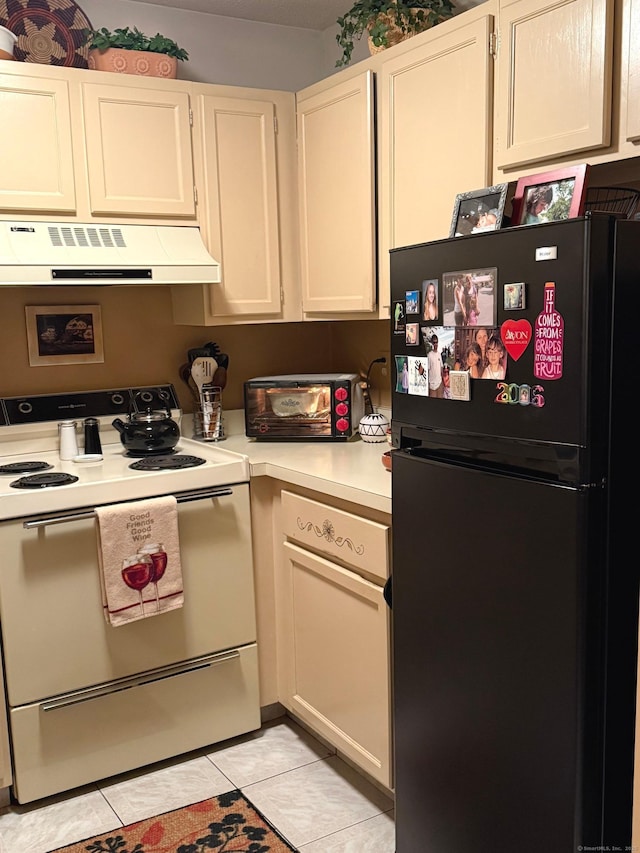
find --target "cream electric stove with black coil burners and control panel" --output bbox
[0,385,260,803]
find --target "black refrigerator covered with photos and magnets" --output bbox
[391,214,640,853]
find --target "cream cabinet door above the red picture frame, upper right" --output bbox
[495,0,612,171]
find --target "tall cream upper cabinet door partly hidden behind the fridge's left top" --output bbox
[379,12,494,310]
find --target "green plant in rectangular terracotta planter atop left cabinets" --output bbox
[86,27,189,77]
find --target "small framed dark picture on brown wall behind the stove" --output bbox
[24,305,104,367]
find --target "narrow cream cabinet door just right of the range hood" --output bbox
[200,95,282,317]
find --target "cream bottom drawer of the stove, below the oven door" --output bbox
[10,645,260,803]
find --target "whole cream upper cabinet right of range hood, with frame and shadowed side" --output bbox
[173,85,301,325]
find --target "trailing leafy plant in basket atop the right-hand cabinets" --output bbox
[336,0,454,68]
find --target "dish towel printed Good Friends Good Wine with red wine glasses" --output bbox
[96,495,184,626]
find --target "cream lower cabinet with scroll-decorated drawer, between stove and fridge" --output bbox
[276,491,392,788]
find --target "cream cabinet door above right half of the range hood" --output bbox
[82,81,196,219]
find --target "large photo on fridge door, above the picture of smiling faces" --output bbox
[442,267,498,326]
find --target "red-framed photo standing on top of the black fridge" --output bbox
[511,163,589,225]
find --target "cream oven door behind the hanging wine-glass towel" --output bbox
[0,484,256,708]
